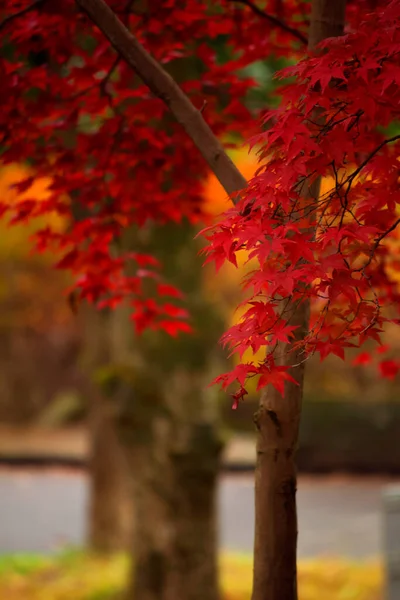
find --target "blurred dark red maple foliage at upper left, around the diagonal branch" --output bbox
[0,0,310,329]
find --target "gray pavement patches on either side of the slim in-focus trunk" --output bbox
[219,477,385,559]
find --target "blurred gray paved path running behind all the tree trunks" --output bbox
[0,469,394,558]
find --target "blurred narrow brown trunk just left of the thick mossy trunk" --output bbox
[83,308,132,553]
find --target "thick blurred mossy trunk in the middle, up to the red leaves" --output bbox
[109,223,225,600]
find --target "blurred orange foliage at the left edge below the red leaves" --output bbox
[0,165,71,331]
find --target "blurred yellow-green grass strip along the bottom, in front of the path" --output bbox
[0,552,383,600]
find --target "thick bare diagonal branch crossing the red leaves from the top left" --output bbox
[75,0,247,203]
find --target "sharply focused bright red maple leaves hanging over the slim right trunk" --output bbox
[206,1,400,398]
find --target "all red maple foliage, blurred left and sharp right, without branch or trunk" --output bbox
[0,1,398,398]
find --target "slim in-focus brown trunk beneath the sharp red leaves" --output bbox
[252,0,346,600]
